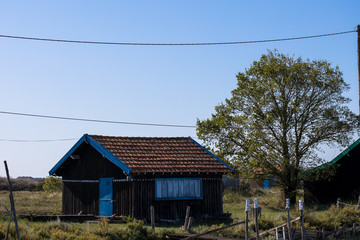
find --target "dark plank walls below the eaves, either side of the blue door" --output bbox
[63,178,223,220]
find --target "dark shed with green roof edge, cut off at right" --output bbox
[304,139,360,204]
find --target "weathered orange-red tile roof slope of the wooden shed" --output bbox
[90,135,231,173]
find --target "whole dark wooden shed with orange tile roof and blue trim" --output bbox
[49,134,233,220]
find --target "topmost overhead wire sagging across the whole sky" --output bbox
[0,30,356,46]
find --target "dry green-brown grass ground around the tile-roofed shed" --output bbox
[0,189,360,240]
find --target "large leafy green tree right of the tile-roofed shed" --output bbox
[197,50,356,204]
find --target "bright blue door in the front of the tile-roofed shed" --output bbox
[99,178,113,217]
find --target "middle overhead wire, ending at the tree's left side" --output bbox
[0,111,196,128]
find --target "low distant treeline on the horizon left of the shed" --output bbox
[0,177,44,191]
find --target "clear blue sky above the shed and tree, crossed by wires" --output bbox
[0,0,360,177]
